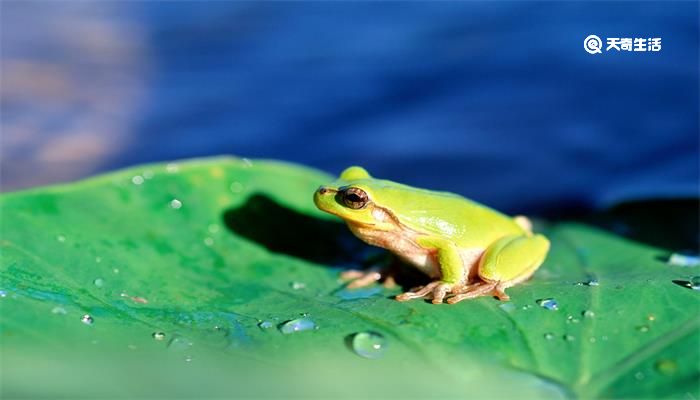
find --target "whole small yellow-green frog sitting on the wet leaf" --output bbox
[313,166,550,304]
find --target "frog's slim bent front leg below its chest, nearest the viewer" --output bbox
[396,239,467,304]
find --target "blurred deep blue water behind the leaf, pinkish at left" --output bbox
[0,1,700,215]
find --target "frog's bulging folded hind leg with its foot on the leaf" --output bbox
[447,234,549,304]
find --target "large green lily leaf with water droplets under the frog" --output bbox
[0,158,700,399]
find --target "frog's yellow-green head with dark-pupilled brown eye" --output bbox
[314,167,393,230]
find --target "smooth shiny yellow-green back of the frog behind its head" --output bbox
[364,181,523,248]
